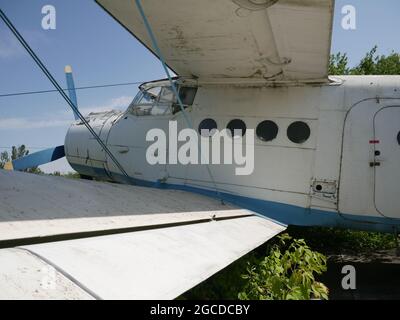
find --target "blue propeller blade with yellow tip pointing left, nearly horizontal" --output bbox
[4,146,65,171]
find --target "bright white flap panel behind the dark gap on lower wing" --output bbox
[0,216,285,299]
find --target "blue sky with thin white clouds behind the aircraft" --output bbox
[0,0,400,172]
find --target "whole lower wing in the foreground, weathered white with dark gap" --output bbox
[0,170,285,299]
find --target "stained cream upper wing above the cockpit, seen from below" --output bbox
[96,0,334,82]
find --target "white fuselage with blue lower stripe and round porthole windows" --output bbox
[65,76,400,231]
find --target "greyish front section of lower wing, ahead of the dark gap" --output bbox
[0,170,252,241]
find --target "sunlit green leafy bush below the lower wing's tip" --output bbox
[238,233,328,300]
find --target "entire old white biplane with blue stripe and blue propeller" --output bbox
[0,0,400,299]
